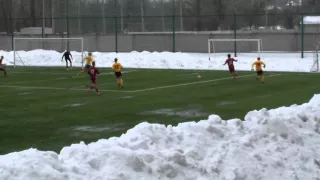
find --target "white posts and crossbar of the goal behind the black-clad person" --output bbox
[13,37,84,67]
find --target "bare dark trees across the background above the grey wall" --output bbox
[0,0,320,34]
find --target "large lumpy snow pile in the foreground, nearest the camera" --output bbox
[0,95,320,180]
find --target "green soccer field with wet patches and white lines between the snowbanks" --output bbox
[0,68,320,154]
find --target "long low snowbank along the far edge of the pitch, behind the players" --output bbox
[0,50,313,72]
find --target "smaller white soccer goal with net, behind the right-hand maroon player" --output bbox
[208,39,263,60]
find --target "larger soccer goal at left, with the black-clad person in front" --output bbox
[12,38,85,67]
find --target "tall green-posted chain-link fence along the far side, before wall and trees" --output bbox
[0,0,320,56]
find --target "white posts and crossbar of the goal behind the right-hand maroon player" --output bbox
[208,39,262,59]
